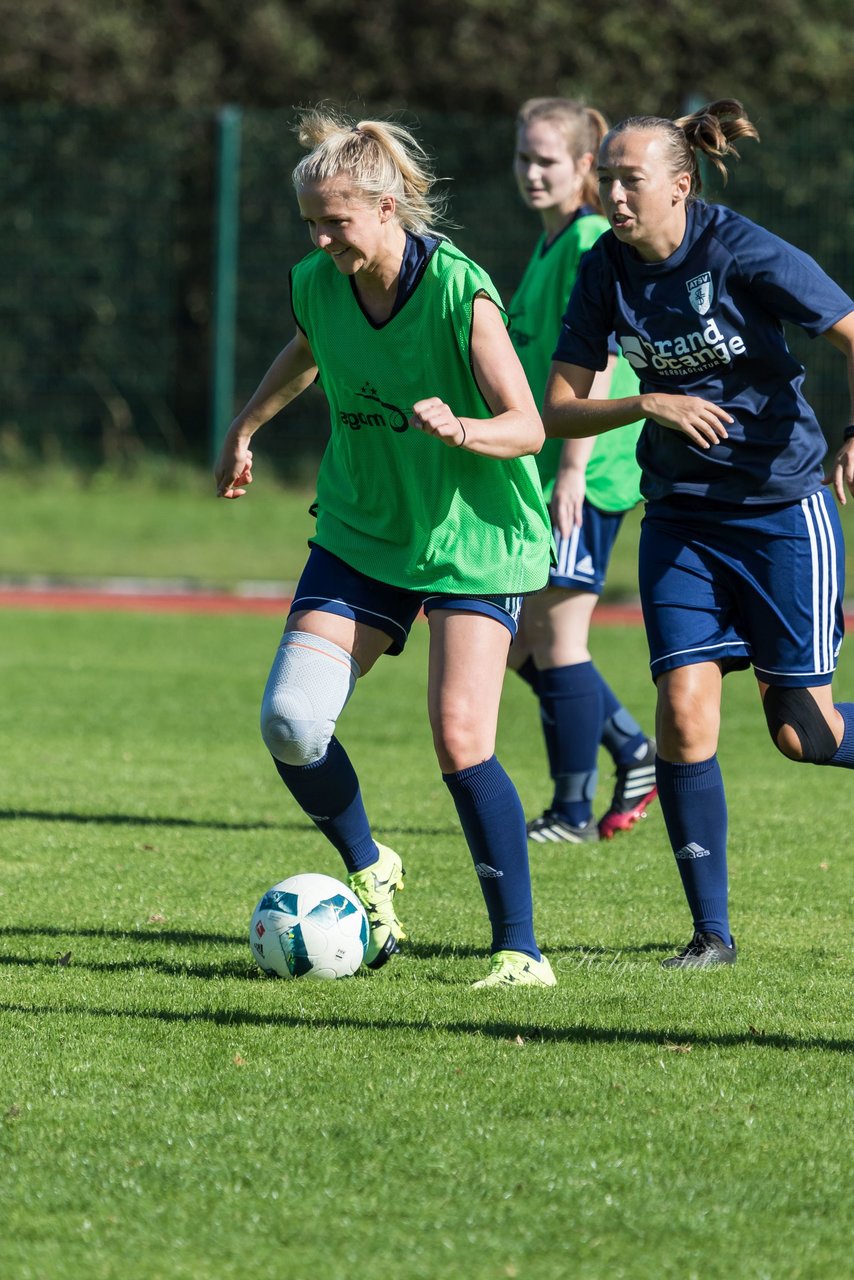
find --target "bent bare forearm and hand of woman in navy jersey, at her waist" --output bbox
[543,360,732,449]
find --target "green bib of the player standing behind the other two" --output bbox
[508,205,643,511]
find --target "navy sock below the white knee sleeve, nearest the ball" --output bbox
[273,737,379,874]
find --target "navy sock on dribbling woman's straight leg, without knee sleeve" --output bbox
[442,755,540,960]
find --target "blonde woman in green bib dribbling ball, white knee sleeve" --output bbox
[216,110,554,987]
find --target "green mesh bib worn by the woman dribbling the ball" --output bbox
[291,239,551,595]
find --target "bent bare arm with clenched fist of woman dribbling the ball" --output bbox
[411,297,545,458]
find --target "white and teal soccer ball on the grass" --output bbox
[250,872,367,980]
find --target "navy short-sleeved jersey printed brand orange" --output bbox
[554,200,854,504]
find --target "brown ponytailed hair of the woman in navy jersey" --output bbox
[608,97,759,200]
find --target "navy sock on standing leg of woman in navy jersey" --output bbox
[656,755,732,946]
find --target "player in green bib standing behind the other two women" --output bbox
[510,97,656,844]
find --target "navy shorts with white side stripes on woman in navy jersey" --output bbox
[640,490,845,689]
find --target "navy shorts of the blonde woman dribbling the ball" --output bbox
[291,545,524,657]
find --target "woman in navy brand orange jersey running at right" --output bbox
[544,100,854,968]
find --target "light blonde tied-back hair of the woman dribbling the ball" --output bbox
[292,108,446,236]
